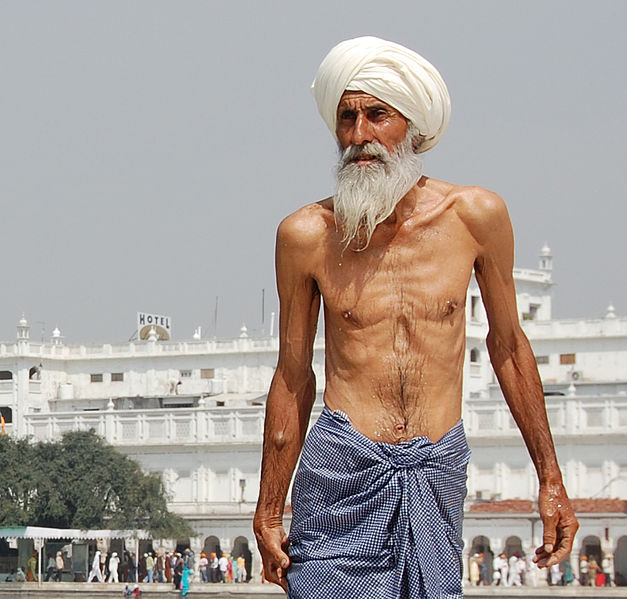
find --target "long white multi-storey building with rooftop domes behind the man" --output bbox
[0,246,627,583]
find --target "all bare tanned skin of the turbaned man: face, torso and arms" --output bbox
[254,92,578,589]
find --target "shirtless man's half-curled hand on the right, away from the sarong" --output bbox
[533,483,579,568]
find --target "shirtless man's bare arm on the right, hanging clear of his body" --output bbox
[471,191,579,568]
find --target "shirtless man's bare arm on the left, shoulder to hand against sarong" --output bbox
[254,209,320,590]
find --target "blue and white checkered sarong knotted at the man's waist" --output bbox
[287,407,470,599]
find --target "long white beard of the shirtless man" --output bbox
[333,124,422,250]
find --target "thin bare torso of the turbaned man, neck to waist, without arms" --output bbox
[313,180,477,443]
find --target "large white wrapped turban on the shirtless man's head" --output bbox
[311,37,451,152]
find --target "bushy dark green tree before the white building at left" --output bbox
[0,431,194,538]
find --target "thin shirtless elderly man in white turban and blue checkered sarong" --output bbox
[255,37,578,599]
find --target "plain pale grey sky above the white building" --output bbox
[0,0,627,343]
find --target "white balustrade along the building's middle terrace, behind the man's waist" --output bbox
[24,396,627,446]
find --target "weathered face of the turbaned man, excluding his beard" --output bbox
[336,91,407,157]
